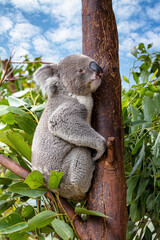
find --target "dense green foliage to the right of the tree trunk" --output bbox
[122,43,160,240]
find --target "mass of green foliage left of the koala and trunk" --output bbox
[0,56,107,240]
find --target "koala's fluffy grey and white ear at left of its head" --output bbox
[33,64,59,95]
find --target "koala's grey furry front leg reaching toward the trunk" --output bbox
[48,103,106,160]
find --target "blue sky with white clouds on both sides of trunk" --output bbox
[0,0,160,86]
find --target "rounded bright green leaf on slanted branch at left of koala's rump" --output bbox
[24,170,44,189]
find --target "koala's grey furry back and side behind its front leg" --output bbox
[32,95,73,178]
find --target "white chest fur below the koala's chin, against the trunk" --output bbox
[71,95,93,124]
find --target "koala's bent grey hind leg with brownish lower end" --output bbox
[59,147,94,200]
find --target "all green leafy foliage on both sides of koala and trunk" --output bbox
[0,43,160,240]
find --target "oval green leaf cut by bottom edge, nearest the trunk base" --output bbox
[51,219,74,240]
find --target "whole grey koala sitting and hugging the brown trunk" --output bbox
[32,54,106,201]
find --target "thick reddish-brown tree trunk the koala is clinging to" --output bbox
[82,0,127,240]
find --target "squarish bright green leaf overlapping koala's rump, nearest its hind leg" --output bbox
[48,171,64,189]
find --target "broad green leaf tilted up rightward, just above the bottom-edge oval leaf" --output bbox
[28,210,57,231]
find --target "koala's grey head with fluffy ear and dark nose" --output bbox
[34,54,103,95]
